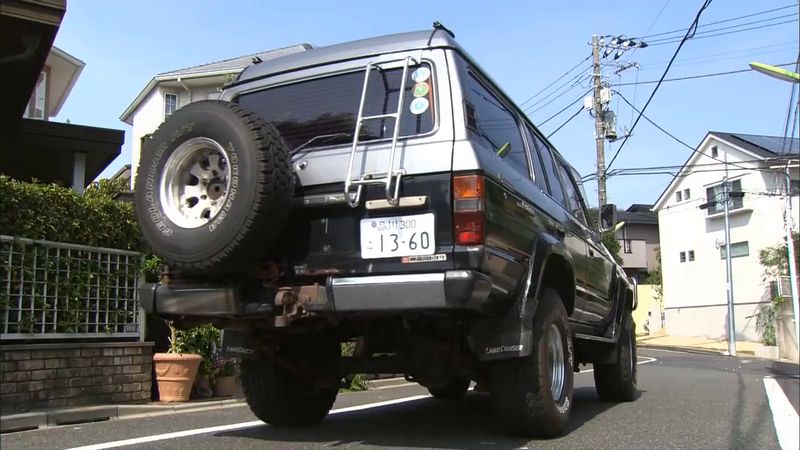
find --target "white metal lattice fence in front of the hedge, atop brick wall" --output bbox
[0,235,142,339]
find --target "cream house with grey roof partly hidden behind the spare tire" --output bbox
[120,44,312,183]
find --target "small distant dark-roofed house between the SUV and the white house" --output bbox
[616,204,658,283]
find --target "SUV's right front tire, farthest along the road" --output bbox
[594,311,638,402]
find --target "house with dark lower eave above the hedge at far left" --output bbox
[0,47,125,193]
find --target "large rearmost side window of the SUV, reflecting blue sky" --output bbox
[464,73,530,179]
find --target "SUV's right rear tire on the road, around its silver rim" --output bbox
[490,288,575,437]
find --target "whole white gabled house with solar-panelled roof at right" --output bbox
[654,131,800,341]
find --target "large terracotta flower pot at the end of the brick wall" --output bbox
[153,353,203,402]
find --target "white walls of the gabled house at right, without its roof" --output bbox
[658,138,800,341]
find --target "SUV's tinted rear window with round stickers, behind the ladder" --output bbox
[238,64,435,150]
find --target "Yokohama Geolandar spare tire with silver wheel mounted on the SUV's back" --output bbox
[135,100,293,275]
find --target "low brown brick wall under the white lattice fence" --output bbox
[0,342,153,413]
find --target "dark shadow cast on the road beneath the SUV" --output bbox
[214,387,616,449]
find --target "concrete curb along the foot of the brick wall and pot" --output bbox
[0,398,245,433]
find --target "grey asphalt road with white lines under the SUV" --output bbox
[0,349,798,450]
